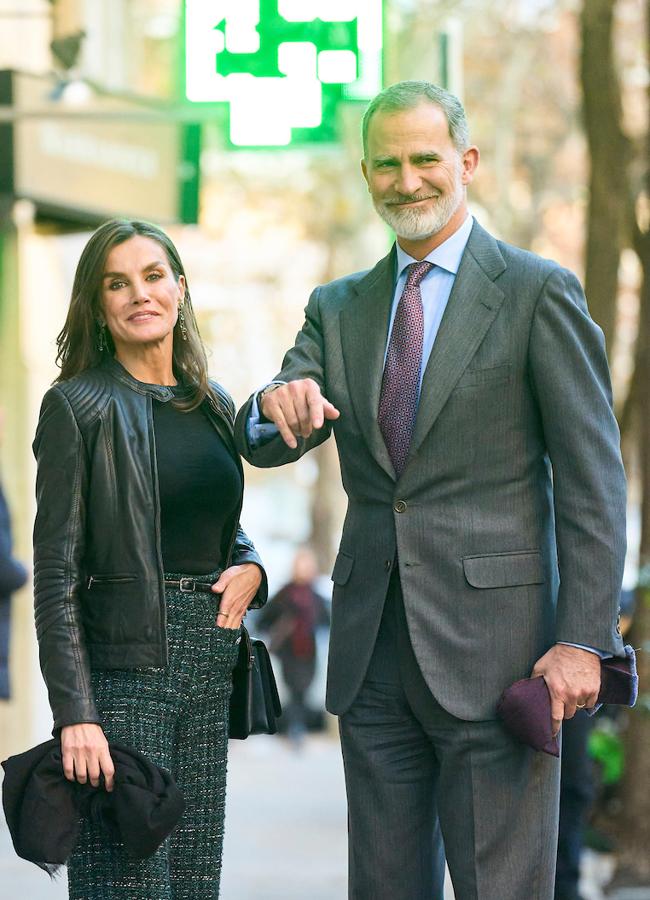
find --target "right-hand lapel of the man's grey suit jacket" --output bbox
[407,223,505,465]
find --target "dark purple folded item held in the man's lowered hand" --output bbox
[497,645,639,756]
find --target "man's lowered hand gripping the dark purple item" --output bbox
[531,644,600,735]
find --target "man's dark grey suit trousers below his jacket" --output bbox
[340,575,560,900]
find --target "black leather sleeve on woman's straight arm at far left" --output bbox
[33,387,100,729]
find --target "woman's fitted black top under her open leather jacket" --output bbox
[153,386,243,575]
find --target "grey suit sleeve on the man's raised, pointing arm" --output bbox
[235,288,332,468]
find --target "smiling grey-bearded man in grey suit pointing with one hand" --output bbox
[237,82,625,900]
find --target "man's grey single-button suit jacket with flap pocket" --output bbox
[236,224,625,720]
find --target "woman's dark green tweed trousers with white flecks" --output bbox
[68,573,239,900]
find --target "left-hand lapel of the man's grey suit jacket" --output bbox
[340,248,395,478]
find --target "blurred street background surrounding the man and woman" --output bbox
[0,0,650,900]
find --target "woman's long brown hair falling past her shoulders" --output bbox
[56,219,212,412]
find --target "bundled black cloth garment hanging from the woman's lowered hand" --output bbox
[2,738,185,874]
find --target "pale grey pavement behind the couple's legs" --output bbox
[0,736,650,900]
